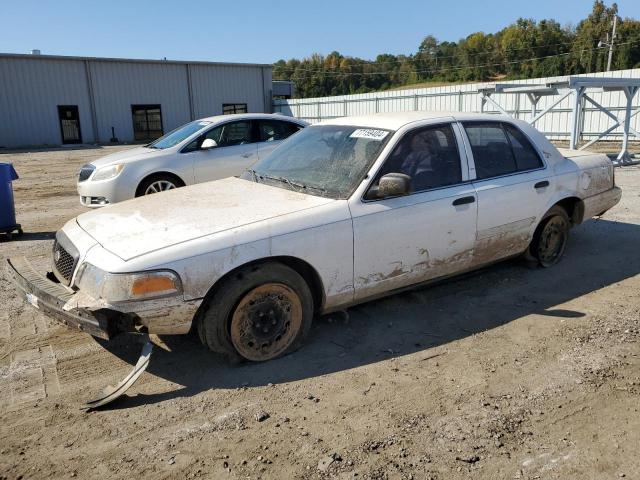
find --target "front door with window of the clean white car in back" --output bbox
[185,120,258,183]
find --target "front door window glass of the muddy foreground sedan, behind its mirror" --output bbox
[377,124,462,192]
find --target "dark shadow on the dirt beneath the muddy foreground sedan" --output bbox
[95,220,640,409]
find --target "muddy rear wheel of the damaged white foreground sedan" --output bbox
[525,205,571,268]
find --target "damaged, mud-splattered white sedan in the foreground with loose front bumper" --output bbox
[9,112,621,404]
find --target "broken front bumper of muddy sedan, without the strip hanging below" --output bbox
[7,257,135,340]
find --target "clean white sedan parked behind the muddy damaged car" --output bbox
[78,114,307,207]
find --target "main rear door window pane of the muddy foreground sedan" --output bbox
[463,122,517,180]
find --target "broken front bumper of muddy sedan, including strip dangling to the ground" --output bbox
[7,257,153,410]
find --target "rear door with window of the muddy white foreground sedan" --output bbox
[462,121,555,266]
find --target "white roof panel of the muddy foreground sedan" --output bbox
[315,111,513,130]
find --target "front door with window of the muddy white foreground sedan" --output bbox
[350,123,477,299]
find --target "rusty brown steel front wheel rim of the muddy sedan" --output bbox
[230,283,302,362]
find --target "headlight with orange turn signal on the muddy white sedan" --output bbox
[76,263,182,303]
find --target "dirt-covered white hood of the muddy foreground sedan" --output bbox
[77,178,334,261]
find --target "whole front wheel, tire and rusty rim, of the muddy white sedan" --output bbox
[198,262,314,362]
